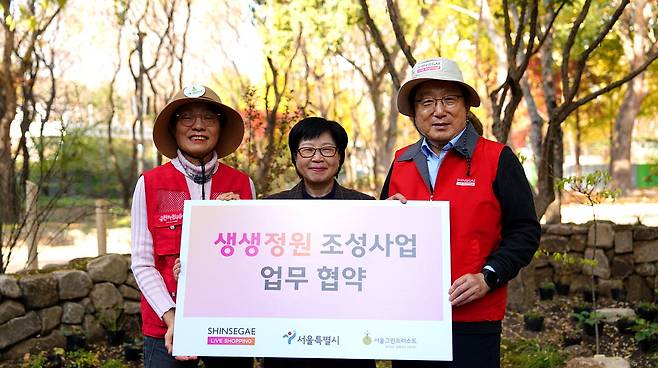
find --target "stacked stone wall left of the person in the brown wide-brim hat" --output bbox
[0,254,141,360]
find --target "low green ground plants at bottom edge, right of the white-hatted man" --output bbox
[500,338,565,368]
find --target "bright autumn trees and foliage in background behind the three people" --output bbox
[0,0,658,273]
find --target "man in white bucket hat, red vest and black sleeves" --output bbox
[381,58,541,368]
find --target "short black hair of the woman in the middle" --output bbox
[288,116,348,177]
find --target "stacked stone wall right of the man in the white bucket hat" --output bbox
[531,222,658,301]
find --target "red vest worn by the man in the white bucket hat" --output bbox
[386,137,507,322]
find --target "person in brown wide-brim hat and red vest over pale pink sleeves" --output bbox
[132,85,255,368]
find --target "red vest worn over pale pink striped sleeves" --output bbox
[142,162,252,338]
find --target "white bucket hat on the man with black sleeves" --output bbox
[398,58,480,116]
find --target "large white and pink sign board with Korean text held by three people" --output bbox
[174,200,451,359]
